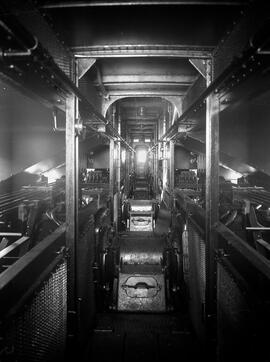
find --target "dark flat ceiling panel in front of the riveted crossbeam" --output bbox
[37,1,246,47]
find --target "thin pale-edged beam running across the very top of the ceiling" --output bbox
[41,0,248,9]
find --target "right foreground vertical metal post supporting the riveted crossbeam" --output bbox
[205,60,219,338]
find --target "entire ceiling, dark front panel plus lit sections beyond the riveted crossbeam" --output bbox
[37,0,247,139]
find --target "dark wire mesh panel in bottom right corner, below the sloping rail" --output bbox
[217,262,264,362]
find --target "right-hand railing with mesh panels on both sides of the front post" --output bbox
[175,192,270,362]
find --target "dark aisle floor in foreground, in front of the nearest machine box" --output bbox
[86,313,200,362]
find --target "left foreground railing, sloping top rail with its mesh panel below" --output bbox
[0,225,67,362]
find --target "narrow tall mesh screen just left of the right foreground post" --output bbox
[187,221,205,340]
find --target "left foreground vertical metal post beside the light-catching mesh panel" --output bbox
[66,96,77,347]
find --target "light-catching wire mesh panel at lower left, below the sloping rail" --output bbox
[1,260,67,362]
